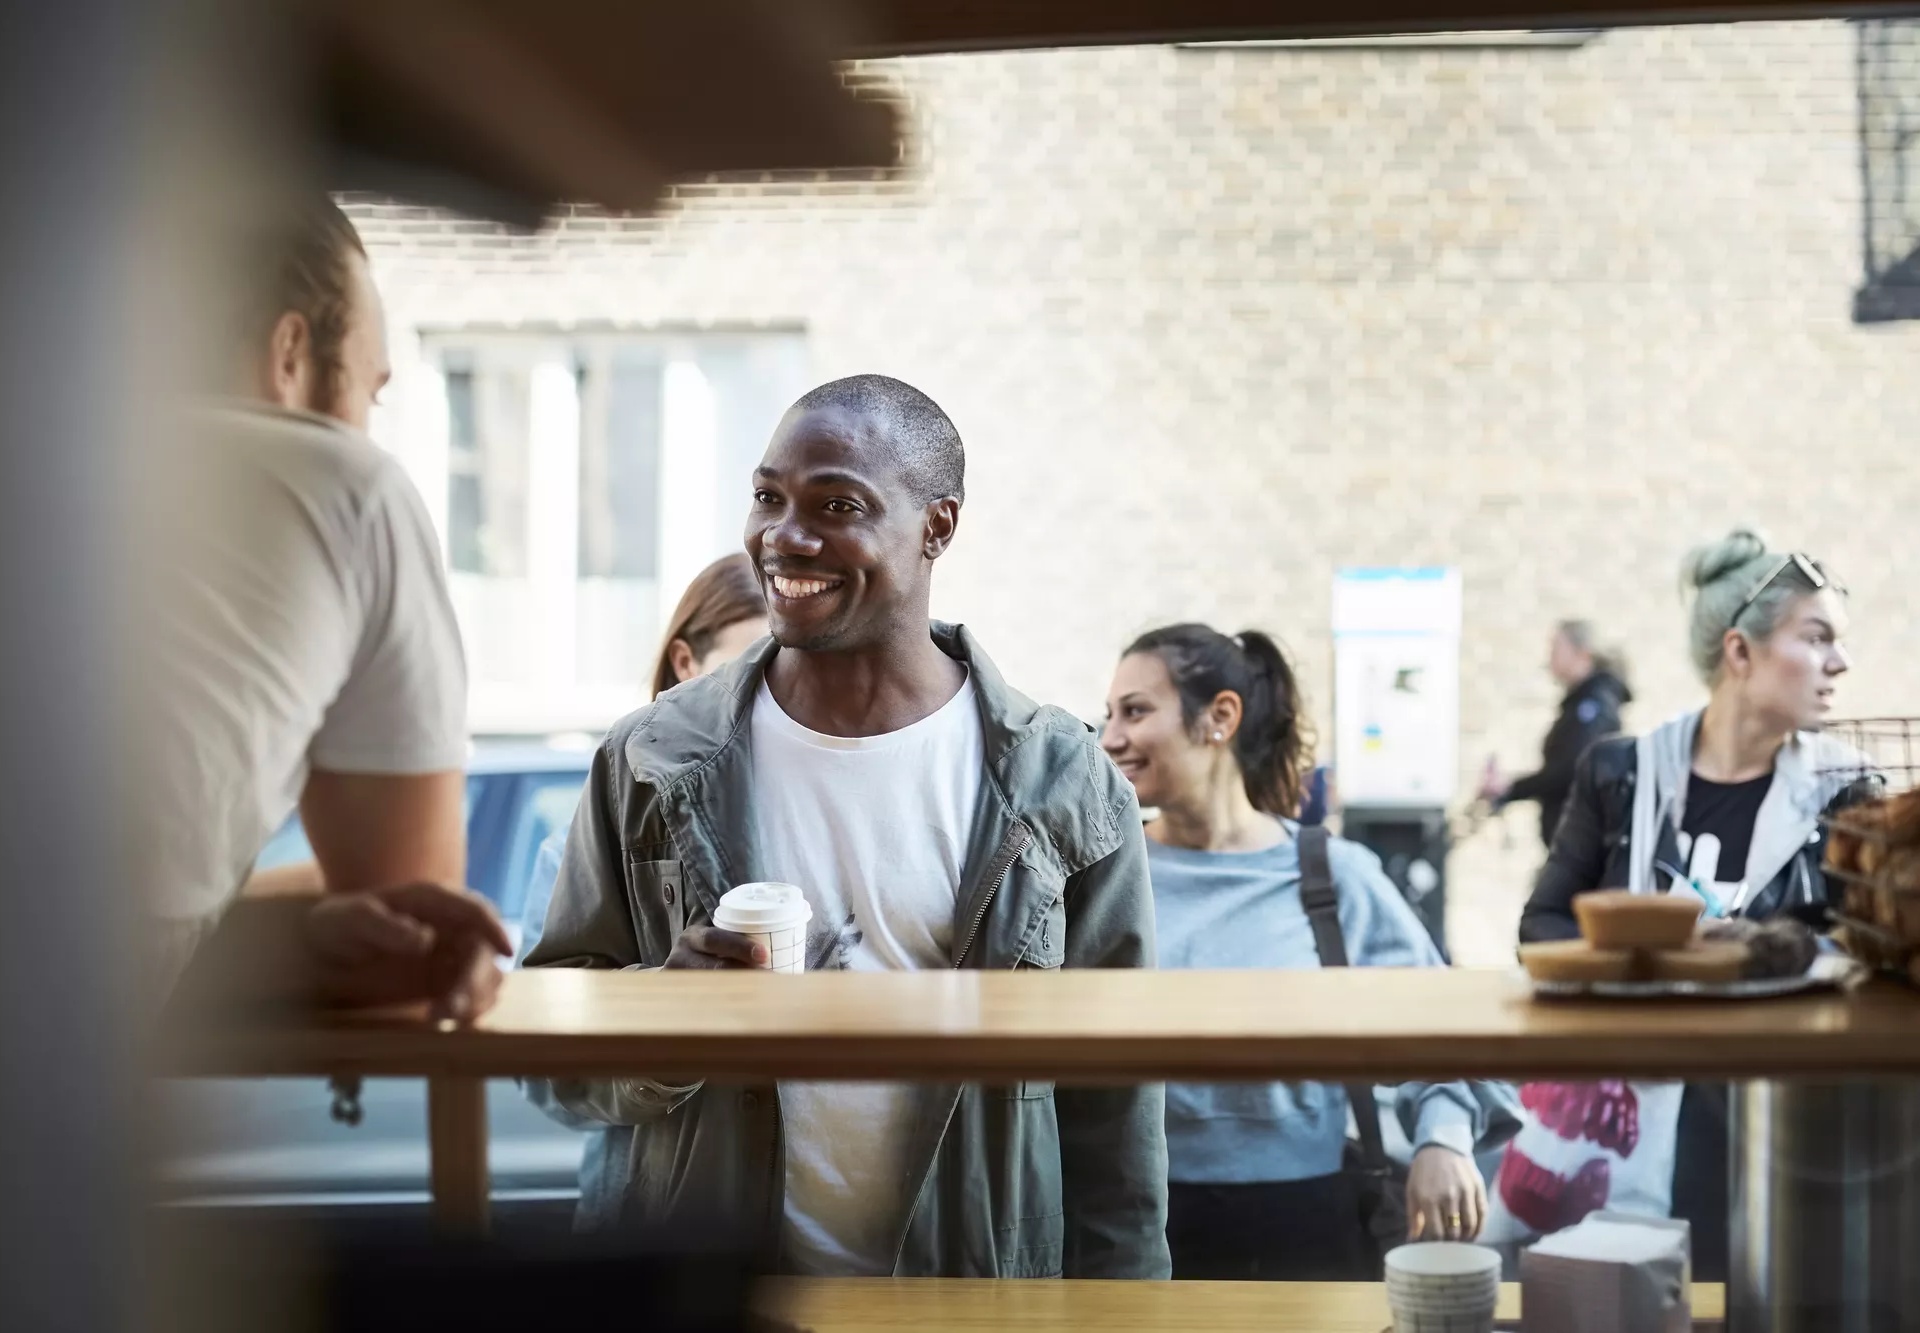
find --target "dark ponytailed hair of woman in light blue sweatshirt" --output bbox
[1125,624,1313,818]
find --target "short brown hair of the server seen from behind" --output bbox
[242,194,367,403]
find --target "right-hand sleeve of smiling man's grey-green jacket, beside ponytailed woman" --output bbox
[1054,772,1173,1279]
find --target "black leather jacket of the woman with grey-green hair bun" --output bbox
[1521,736,1872,943]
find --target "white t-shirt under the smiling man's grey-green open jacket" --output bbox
[753,680,987,1275]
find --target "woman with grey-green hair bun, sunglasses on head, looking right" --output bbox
[1496,528,1864,1279]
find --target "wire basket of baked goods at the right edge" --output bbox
[1820,718,1920,983]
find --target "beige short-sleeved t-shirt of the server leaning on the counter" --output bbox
[132,405,467,982]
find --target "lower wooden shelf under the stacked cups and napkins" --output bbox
[755,1277,1724,1333]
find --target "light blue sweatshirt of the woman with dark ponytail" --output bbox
[1146,837,1488,1185]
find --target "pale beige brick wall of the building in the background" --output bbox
[355,23,1920,958]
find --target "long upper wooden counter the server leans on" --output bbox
[165,968,1920,1081]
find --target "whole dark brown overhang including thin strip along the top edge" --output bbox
[303,0,1920,218]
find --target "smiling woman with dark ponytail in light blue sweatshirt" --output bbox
[1102,624,1503,1281]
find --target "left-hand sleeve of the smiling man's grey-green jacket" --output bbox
[520,732,701,1127]
